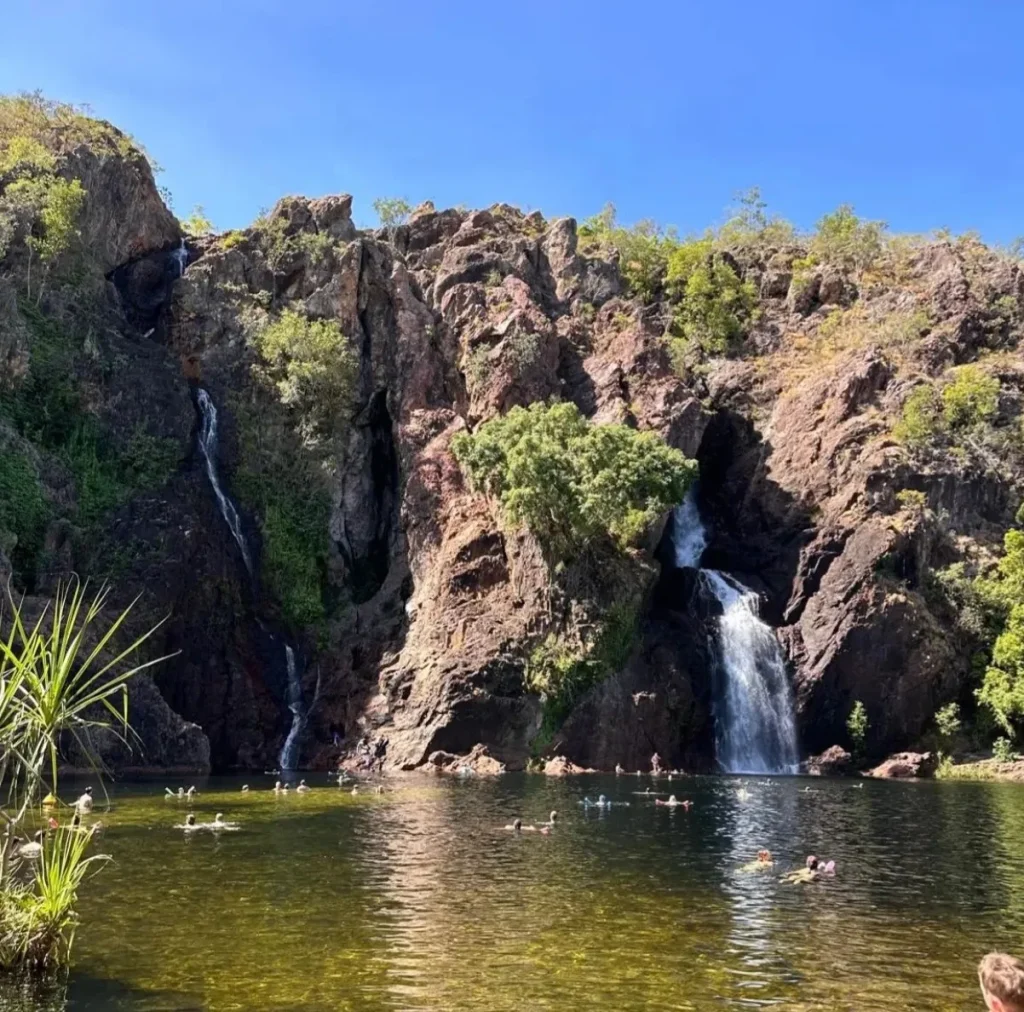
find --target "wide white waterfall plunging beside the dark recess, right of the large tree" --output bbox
[672,490,799,773]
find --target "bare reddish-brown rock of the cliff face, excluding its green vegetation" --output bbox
[8,118,1024,768]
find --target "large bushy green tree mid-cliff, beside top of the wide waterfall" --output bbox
[452,404,696,555]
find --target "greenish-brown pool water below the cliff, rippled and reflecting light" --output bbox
[6,776,1024,1012]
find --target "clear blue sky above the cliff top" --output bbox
[0,0,1024,242]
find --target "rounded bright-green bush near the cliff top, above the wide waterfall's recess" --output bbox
[666,239,758,354]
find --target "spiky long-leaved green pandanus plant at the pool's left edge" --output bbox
[0,580,166,969]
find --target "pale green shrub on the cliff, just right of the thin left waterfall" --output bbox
[255,309,359,442]
